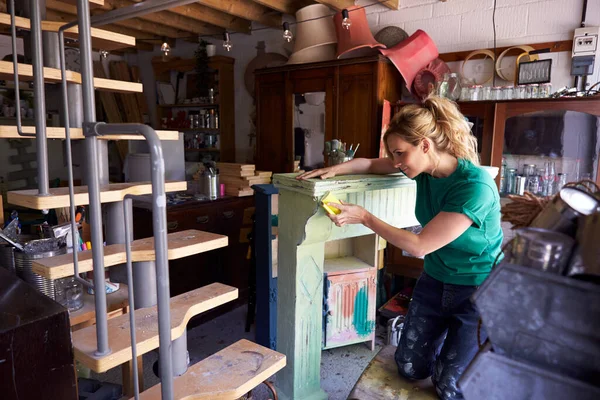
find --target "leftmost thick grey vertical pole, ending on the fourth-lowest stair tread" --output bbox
[29,0,50,196]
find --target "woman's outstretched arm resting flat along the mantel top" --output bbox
[297,158,398,179]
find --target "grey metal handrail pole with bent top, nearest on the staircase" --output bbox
[94,122,173,400]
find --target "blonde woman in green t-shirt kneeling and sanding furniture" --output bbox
[298,97,502,400]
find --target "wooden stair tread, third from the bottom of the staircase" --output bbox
[31,229,228,279]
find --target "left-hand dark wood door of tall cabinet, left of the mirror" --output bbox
[255,75,294,172]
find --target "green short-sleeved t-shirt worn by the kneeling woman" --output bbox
[414,159,503,286]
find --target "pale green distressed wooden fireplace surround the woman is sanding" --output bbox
[273,174,417,400]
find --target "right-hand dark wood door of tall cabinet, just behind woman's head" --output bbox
[337,73,379,157]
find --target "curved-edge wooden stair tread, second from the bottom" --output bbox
[72,283,238,373]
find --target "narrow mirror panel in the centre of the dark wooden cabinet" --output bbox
[294,92,325,171]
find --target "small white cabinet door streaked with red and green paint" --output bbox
[323,268,377,349]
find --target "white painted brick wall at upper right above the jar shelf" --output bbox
[356,0,600,89]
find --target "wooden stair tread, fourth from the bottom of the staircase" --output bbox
[7,181,187,210]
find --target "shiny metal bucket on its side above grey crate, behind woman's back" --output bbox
[510,228,575,274]
